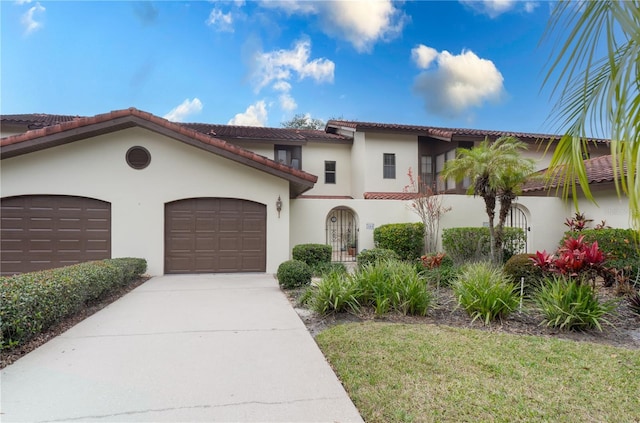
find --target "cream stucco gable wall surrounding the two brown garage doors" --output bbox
[0,128,290,275]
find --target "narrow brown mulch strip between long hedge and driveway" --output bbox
[0,276,150,369]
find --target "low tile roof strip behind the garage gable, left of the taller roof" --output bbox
[180,123,351,142]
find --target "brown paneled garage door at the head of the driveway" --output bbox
[164,198,267,273]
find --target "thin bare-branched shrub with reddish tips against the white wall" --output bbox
[404,168,451,254]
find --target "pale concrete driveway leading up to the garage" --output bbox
[0,274,362,422]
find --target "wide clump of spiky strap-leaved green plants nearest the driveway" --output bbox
[312,260,432,315]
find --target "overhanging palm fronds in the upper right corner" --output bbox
[545,0,640,231]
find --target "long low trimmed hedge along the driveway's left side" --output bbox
[0,258,147,348]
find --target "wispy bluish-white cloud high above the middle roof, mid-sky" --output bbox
[253,41,335,92]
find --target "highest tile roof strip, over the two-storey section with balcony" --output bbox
[327,120,609,143]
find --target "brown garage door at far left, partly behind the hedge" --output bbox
[0,195,111,275]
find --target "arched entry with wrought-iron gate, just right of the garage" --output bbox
[325,207,358,261]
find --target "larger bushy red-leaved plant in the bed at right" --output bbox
[531,235,606,283]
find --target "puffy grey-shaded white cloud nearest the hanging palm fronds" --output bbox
[412,47,505,117]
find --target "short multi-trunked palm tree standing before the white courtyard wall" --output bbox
[442,137,534,263]
